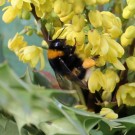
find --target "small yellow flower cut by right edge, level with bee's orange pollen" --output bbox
[126,56,135,71]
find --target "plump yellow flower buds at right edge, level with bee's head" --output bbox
[121,25,135,46]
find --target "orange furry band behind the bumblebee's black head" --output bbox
[47,49,64,59]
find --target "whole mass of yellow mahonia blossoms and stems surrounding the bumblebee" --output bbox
[0,0,135,119]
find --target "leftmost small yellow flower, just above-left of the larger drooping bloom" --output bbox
[8,33,27,55]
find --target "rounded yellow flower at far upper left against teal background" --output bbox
[2,6,20,23]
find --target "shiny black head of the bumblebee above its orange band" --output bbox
[49,39,65,50]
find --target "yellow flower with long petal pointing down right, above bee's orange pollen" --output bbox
[88,30,125,70]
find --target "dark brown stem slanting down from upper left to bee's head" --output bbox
[31,4,51,45]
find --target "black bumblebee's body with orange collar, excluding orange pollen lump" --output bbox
[48,39,96,89]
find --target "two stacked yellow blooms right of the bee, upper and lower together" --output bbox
[88,10,125,70]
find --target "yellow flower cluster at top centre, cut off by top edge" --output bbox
[54,0,109,23]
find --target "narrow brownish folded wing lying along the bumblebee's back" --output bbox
[59,58,88,89]
